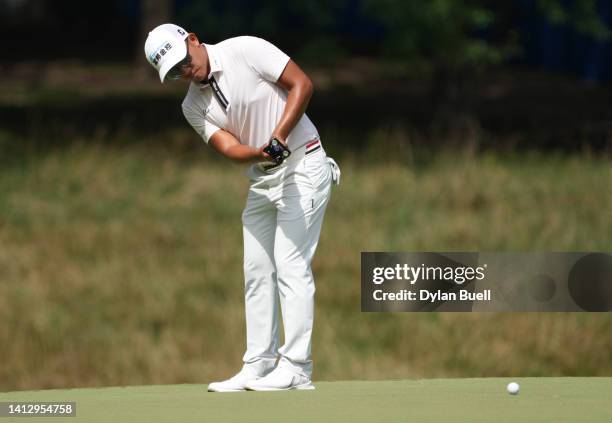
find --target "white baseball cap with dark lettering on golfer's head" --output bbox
[145,24,189,83]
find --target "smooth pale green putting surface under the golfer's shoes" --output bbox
[0,378,612,423]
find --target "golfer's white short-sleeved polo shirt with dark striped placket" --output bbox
[182,36,319,150]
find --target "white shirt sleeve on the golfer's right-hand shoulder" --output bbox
[244,37,290,82]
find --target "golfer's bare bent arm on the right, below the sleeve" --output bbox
[272,60,313,140]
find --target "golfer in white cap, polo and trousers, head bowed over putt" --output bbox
[145,24,340,392]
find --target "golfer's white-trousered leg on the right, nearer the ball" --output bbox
[274,161,331,377]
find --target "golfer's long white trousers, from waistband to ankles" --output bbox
[242,142,339,377]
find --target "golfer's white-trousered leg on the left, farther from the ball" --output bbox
[242,187,279,373]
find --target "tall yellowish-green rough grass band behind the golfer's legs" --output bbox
[0,143,612,391]
